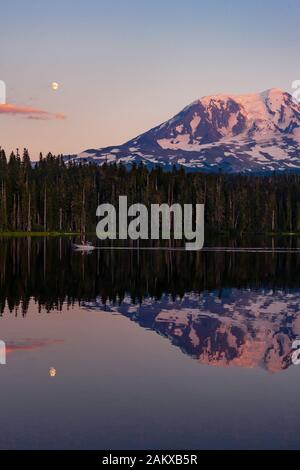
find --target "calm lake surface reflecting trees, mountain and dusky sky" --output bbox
[0,238,300,449]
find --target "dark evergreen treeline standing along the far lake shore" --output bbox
[0,149,300,233]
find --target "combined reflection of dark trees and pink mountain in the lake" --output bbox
[0,237,300,371]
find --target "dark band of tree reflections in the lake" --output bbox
[0,238,300,314]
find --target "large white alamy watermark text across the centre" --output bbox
[96,196,204,250]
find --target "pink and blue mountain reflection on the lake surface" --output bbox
[85,289,300,372]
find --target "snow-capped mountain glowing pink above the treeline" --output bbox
[69,88,300,173]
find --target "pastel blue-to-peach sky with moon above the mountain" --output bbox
[0,0,300,160]
